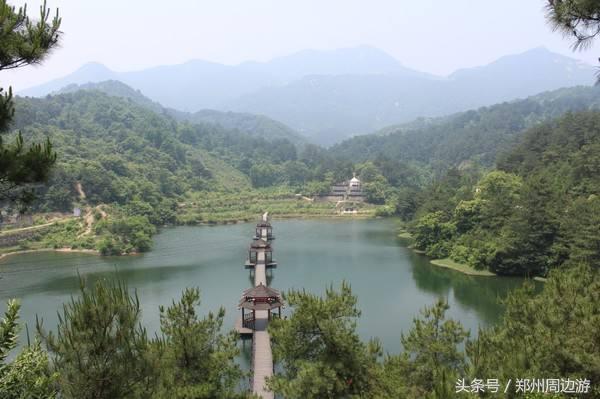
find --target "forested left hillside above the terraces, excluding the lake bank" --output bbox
[14,87,426,210]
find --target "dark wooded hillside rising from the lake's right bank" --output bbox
[413,111,600,275]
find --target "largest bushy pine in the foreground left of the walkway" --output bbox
[38,280,156,399]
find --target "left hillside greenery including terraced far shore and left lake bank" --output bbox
[4,89,406,255]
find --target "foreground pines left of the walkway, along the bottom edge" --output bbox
[32,280,246,399]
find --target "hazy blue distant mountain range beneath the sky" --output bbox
[18,46,595,145]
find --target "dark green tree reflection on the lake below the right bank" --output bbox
[409,253,539,324]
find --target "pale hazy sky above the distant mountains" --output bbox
[5,0,600,91]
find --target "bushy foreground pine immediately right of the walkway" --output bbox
[268,283,381,399]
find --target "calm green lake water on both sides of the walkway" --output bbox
[0,219,522,364]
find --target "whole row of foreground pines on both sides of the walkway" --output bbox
[0,264,600,399]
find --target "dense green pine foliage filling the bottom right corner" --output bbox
[467,264,600,398]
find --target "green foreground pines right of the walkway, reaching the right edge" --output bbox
[269,265,600,398]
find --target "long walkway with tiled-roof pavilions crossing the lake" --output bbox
[235,212,283,399]
